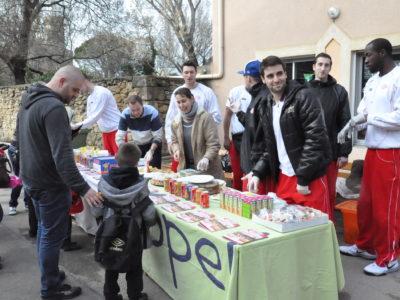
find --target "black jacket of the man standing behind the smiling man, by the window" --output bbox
[307,75,352,161]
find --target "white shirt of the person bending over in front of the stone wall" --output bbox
[78,85,121,133]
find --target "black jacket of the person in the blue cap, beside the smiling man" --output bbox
[236,81,269,174]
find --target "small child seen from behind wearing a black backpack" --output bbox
[93,143,156,300]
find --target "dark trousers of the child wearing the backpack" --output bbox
[103,254,143,299]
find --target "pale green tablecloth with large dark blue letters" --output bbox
[143,187,344,300]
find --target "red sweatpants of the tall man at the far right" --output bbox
[356,149,400,266]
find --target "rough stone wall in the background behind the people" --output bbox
[0,76,182,153]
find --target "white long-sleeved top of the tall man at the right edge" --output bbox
[357,67,400,149]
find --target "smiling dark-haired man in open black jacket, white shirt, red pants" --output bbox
[249,56,332,217]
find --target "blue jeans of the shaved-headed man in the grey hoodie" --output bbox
[25,186,72,296]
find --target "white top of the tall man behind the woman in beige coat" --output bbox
[165,83,222,143]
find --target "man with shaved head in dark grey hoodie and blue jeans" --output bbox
[17,65,102,299]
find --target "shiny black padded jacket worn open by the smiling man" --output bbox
[253,81,332,185]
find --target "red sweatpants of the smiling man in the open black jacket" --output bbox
[276,172,333,220]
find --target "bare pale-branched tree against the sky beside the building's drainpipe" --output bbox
[131,0,212,74]
